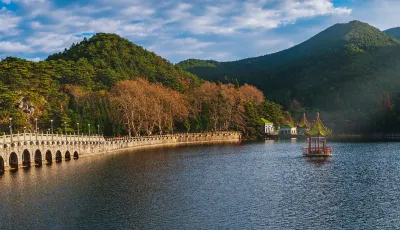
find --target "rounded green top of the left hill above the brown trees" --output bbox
[47,33,198,91]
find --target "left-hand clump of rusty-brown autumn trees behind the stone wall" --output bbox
[109,79,188,136]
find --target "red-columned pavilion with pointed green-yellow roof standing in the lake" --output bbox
[303,113,332,157]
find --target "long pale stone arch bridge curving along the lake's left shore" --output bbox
[0,132,241,174]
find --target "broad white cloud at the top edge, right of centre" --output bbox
[162,0,351,34]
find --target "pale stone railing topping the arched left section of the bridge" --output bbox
[0,133,105,145]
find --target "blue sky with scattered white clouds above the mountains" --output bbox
[0,0,400,63]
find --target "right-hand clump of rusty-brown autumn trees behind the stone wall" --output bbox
[187,82,264,134]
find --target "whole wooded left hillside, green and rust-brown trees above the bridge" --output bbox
[0,33,293,137]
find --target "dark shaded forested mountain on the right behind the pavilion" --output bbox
[178,21,400,132]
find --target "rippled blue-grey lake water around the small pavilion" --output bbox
[0,141,400,229]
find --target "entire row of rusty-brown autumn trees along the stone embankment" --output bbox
[109,79,282,136]
